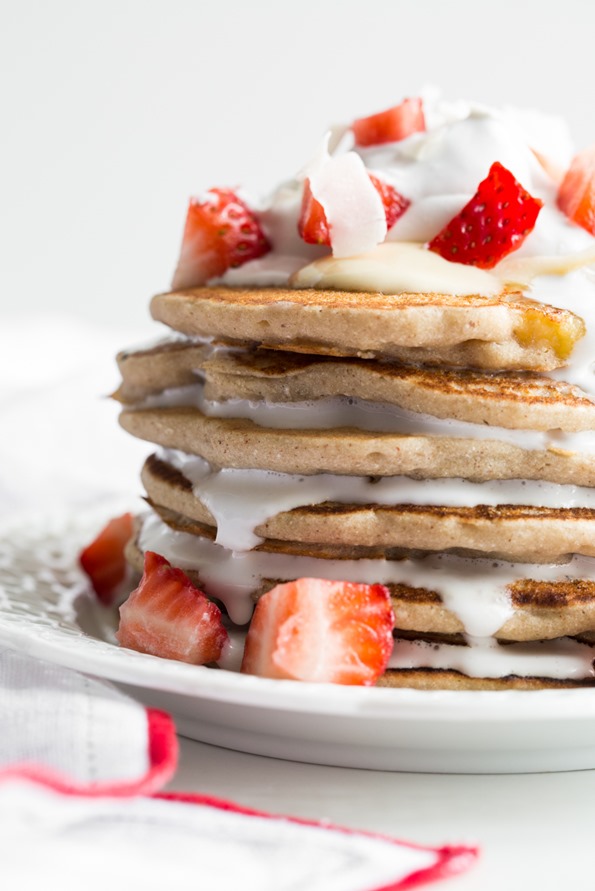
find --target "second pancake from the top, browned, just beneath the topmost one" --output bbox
[116,341,595,432]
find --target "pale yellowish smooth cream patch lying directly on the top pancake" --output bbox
[290,242,502,297]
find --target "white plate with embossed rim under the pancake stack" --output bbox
[0,511,595,773]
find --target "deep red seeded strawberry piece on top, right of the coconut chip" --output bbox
[428,161,543,269]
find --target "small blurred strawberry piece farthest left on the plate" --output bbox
[79,514,133,606]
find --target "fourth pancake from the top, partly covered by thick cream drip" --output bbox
[141,455,595,563]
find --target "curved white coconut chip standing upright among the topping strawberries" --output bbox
[304,133,387,257]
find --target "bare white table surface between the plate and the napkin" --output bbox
[168,739,595,891]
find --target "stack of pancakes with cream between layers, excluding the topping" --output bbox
[117,284,595,690]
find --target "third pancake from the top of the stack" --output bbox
[120,406,595,486]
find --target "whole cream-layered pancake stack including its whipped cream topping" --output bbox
[115,92,595,690]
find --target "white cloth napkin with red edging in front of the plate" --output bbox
[0,648,475,891]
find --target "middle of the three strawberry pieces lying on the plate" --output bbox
[116,551,227,665]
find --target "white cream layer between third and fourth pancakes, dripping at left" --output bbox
[157,449,595,550]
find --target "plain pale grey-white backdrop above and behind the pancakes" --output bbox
[0,0,595,330]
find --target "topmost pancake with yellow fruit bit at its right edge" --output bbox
[151,287,585,371]
